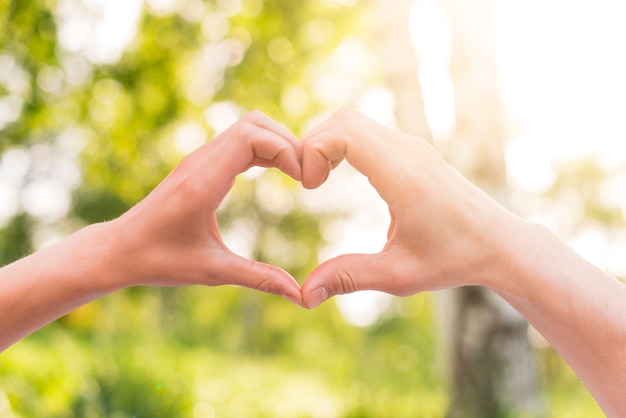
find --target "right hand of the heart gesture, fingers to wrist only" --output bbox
[302,109,511,308]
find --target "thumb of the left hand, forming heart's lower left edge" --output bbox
[214,252,303,306]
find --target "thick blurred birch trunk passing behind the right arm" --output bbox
[444,0,542,418]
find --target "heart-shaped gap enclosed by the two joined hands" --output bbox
[219,164,389,306]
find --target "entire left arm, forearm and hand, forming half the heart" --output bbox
[0,112,301,351]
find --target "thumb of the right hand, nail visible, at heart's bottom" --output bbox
[302,253,385,309]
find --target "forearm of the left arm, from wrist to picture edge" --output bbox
[0,223,122,351]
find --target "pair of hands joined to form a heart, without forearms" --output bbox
[113,109,510,308]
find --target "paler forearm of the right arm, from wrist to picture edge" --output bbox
[490,220,626,417]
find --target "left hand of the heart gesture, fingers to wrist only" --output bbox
[112,112,301,304]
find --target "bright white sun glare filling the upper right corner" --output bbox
[496,0,626,171]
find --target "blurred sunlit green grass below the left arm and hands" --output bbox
[0,288,445,417]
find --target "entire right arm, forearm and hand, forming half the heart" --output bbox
[302,109,626,417]
